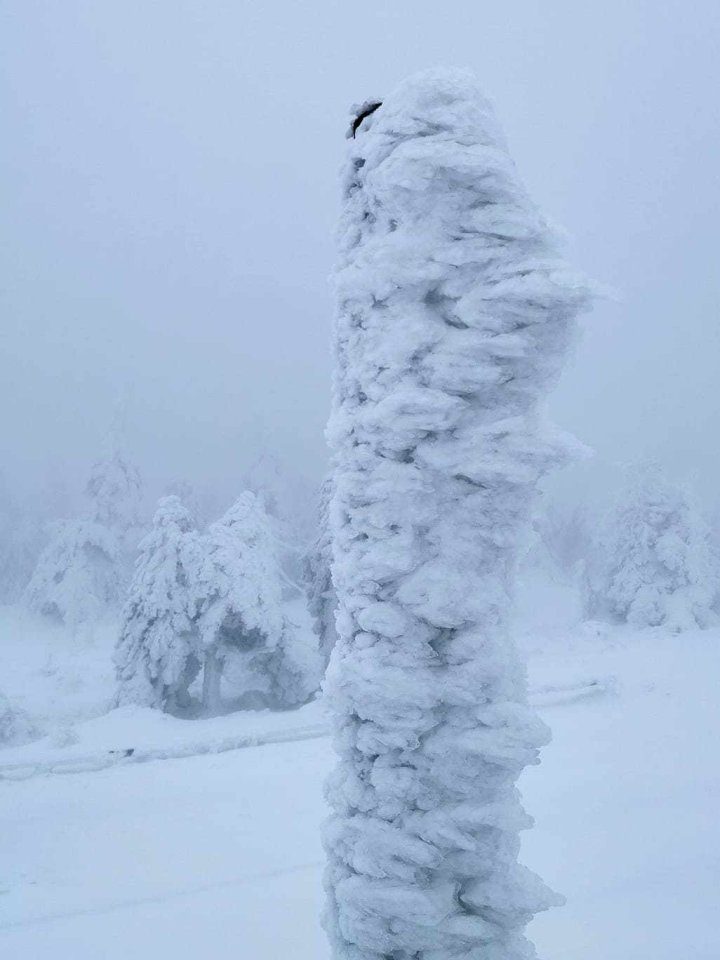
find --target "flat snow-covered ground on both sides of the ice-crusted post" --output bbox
[0,585,720,960]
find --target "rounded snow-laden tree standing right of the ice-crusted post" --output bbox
[588,462,718,630]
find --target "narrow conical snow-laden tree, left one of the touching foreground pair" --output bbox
[115,496,202,713]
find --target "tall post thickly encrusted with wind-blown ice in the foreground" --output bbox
[325,71,590,960]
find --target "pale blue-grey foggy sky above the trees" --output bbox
[0,0,720,512]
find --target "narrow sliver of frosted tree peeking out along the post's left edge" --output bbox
[303,478,337,665]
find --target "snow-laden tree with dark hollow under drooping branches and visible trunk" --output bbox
[198,491,320,713]
